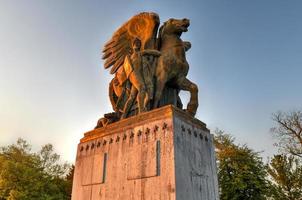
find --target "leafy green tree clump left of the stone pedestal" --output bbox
[0,139,71,200]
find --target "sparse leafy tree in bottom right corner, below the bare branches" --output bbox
[267,155,302,200]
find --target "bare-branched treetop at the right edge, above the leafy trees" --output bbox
[271,110,302,158]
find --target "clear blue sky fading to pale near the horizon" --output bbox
[0,0,302,162]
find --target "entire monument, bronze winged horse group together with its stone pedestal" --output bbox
[72,12,219,200]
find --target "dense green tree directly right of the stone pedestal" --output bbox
[215,130,268,200]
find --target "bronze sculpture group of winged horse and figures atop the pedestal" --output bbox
[98,12,198,126]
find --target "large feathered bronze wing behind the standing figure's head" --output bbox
[102,12,159,74]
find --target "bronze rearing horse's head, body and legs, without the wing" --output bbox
[153,19,198,116]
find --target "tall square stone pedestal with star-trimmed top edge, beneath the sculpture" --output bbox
[72,106,218,200]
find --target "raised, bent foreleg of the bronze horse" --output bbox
[178,78,198,116]
